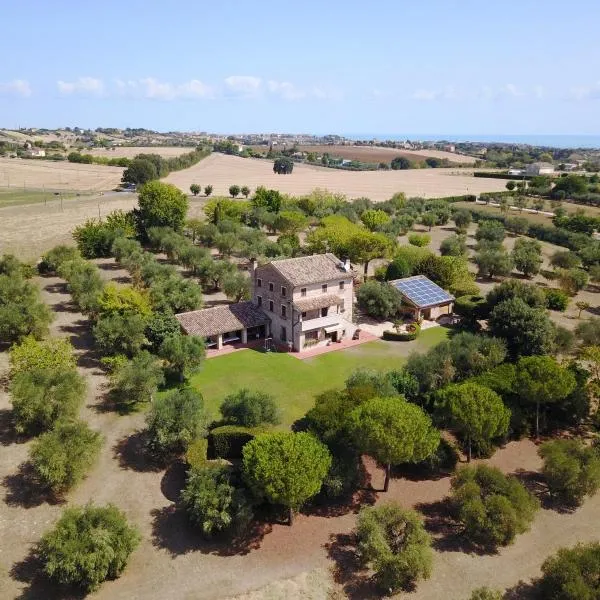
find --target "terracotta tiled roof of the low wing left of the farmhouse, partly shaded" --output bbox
[175,302,269,337]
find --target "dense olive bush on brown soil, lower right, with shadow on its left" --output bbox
[452,465,539,548]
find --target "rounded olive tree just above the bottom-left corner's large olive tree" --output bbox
[30,421,102,492]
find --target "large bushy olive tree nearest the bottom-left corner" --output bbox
[38,504,141,591]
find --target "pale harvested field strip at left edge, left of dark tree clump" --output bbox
[0,158,123,191]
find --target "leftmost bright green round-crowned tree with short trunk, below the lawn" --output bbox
[243,432,331,525]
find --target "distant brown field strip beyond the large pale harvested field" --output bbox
[296,145,477,165]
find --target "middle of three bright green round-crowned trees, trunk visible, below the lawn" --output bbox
[349,396,440,492]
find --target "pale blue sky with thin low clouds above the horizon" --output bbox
[0,0,600,134]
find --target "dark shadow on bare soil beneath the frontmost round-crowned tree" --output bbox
[150,504,273,558]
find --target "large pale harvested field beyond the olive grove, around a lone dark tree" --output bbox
[165,153,506,202]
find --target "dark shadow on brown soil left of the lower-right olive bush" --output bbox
[415,498,497,556]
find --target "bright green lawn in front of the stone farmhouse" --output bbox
[191,327,449,427]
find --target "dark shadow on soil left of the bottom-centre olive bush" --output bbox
[325,533,382,600]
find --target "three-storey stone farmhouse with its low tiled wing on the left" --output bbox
[177,253,356,352]
